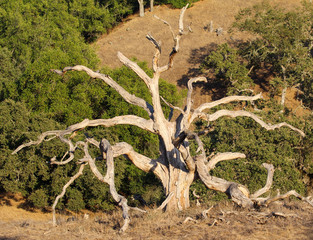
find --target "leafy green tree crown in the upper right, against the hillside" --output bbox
[234,2,313,107]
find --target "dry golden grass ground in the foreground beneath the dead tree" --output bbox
[0,196,313,240]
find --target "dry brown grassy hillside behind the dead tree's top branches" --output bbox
[94,0,301,106]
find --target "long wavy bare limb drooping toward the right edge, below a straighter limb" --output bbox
[207,110,305,137]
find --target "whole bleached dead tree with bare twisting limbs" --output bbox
[14,6,313,230]
